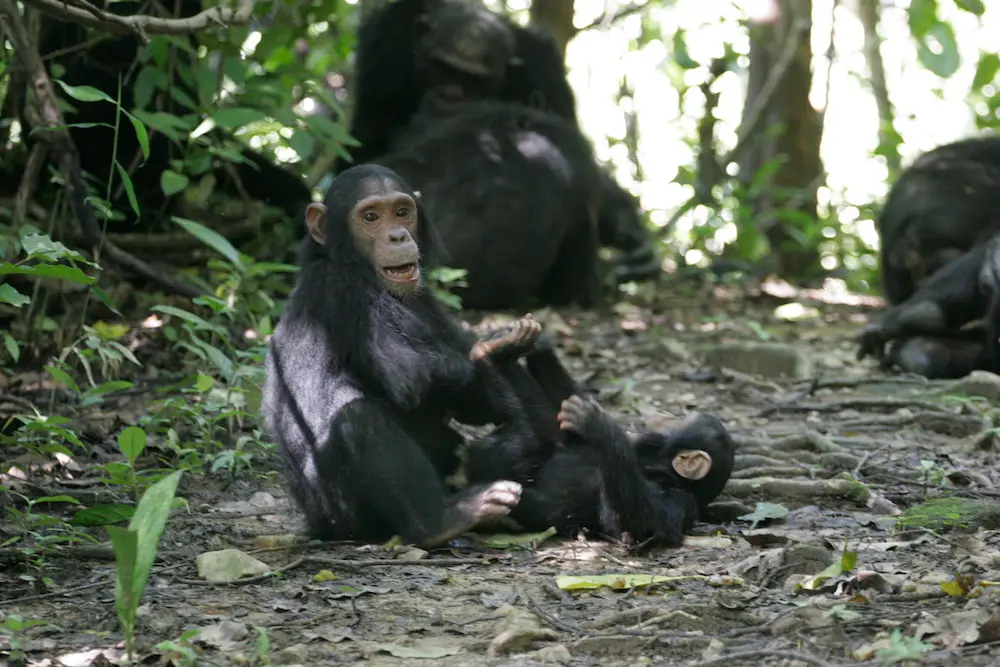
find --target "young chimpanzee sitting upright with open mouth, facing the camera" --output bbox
[264,165,568,545]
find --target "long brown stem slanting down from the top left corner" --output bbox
[0,0,204,298]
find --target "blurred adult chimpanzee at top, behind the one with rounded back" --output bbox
[337,0,660,300]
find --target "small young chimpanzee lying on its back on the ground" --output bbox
[466,334,735,546]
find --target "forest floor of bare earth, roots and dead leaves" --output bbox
[0,276,1000,667]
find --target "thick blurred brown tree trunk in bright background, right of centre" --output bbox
[738,0,823,278]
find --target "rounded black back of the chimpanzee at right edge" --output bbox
[878,136,1000,304]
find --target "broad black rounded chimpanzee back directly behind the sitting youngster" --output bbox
[370,90,601,308]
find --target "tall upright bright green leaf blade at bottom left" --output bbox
[107,470,183,661]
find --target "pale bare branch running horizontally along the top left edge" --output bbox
[24,0,253,42]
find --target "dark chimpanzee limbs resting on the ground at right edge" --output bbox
[858,235,1000,378]
